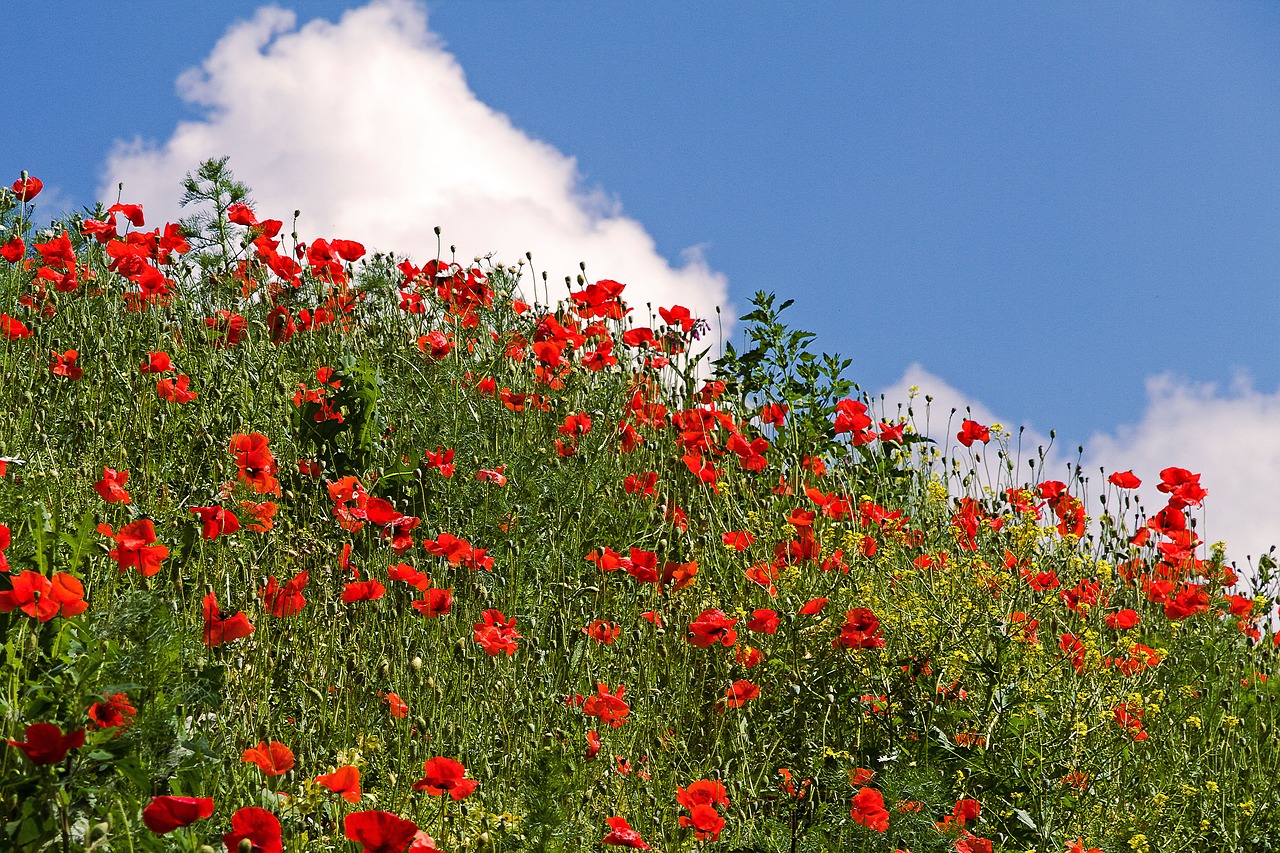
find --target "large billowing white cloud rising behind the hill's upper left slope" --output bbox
[100,0,732,325]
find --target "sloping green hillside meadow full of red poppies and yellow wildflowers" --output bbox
[0,160,1280,853]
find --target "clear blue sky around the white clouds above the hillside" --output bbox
[0,0,1280,555]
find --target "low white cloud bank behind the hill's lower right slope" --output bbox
[882,364,1280,569]
